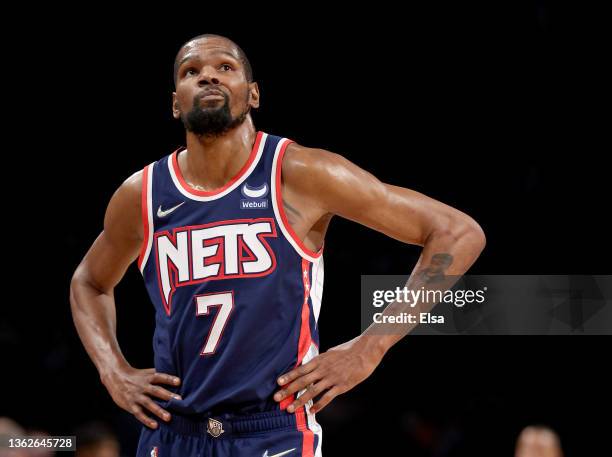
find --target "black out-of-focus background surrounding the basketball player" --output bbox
[0,1,612,456]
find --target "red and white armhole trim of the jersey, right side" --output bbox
[271,138,325,263]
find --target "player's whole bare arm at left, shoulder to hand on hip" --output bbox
[70,171,180,428]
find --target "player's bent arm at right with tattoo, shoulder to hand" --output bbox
[274,145,485,413]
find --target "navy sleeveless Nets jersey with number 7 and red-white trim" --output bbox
[138,132,323,421]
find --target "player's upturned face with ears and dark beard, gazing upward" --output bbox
[172,37,259,135]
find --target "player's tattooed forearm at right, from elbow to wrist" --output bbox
[359,223,485,357]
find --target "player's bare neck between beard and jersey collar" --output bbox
[178,116,257,191]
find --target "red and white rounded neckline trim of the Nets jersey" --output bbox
[168,131,265,201]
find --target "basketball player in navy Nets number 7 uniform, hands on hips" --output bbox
[71,35,485,457]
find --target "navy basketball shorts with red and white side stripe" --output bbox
[137,407,322,457]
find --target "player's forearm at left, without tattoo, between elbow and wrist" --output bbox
[70,270,129,380]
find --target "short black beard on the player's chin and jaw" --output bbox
[181,93,251,136]
